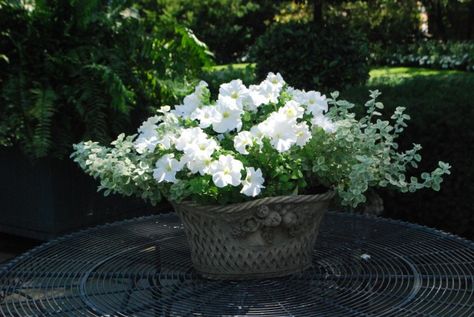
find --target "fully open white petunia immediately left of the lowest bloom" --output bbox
[209,155,244,187]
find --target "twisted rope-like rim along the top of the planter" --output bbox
[171,190,336,214]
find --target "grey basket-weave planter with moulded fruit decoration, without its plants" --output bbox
[174,192,334,279]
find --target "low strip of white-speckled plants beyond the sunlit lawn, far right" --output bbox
[371,40,474,71]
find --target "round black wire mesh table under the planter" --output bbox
[0,213,474,317]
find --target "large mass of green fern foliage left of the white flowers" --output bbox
[0,0,211,158]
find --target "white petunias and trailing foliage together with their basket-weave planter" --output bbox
[72,73,450,279]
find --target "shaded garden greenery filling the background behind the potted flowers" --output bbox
[0,0,474,238]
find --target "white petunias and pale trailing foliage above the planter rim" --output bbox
[72,73,450,207]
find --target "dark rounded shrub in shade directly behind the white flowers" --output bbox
[252,23,369,91]
